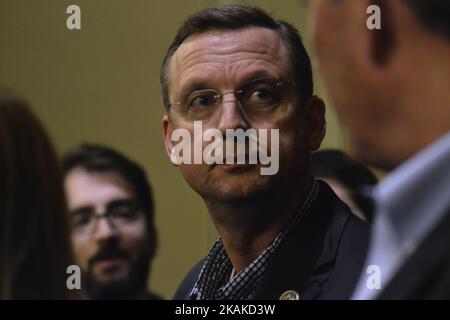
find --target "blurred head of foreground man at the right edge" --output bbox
[309,0,450,169]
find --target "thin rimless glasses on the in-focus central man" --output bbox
[167,78,294,121]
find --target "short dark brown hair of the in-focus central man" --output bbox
[160,5,313,108]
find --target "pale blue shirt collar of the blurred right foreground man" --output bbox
[374,131,450,249]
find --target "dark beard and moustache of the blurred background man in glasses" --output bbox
[84,241,150,300]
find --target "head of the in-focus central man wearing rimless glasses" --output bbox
[161,6,325,212]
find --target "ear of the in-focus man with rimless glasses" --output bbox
[304,96,326,151]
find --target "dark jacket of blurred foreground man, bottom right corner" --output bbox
[378,210,450,300]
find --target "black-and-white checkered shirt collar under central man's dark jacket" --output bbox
[190,181,319,300]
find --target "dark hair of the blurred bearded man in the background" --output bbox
[63,143,155,233]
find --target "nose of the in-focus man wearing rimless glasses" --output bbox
[217,93,249,134]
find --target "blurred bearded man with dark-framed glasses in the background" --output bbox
[63,144,162,299]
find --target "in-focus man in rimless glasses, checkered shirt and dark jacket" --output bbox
[161,6,368,300]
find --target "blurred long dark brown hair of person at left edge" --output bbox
[0,88,74,300]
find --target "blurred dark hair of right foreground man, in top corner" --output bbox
[403,0,450,41]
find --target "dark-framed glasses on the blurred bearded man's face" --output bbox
[70,199,142,235]
